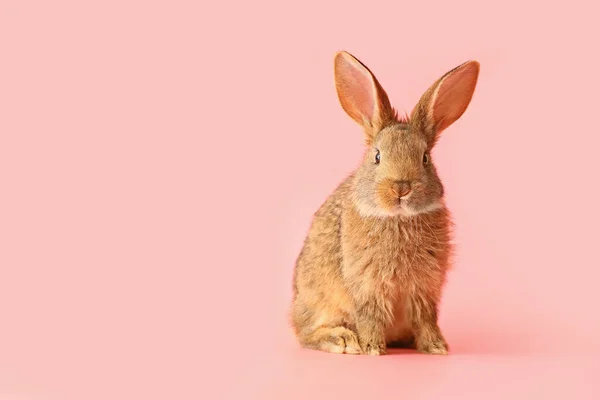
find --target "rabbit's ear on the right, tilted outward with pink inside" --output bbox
[411,61,479,146]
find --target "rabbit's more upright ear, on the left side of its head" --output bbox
[334,51,396,144]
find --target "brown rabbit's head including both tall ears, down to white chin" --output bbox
[335,52,479,217]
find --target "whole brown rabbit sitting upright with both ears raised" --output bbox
[291,52,479,355]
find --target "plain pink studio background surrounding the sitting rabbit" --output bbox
[0,0,600,400]
